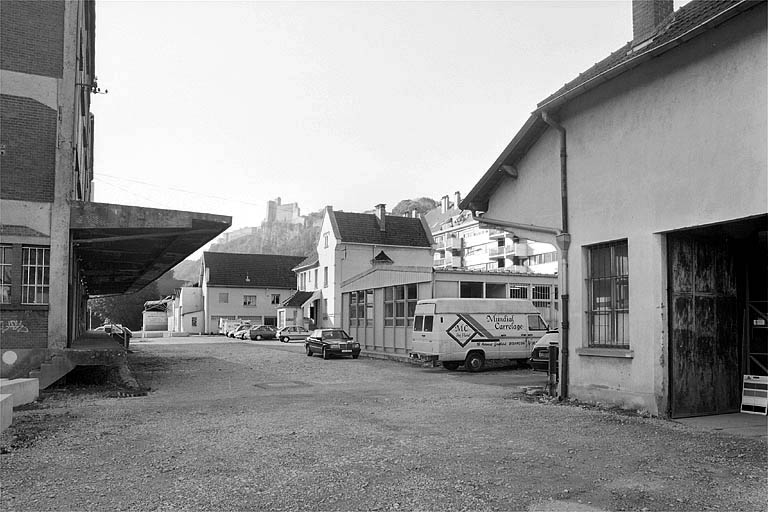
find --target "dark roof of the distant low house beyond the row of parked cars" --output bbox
[203,252,304,289]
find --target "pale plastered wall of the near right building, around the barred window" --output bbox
[480,12,768,413]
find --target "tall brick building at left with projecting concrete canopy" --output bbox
[0,0,231,387]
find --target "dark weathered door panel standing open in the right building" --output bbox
[667,234,741,417]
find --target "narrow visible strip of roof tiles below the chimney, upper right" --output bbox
[538,0,752,107]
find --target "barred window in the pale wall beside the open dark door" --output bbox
[587,240,629,348]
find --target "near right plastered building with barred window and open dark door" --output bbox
[460,0,768,417]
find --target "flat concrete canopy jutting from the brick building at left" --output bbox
[70,202,232,296]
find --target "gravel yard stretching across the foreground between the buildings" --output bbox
[0,338,768,511]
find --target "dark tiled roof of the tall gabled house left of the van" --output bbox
[333,212,432,247]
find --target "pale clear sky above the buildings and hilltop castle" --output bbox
[91,0,686,234]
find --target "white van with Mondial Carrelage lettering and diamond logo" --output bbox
[409,299,548,372]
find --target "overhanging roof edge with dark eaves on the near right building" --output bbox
[459,0,765,212]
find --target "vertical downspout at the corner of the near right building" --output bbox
[541,112,571,400]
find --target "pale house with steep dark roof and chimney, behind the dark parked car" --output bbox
[286,204,433,327]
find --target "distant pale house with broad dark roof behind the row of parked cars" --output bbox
[199,252,304,334]
